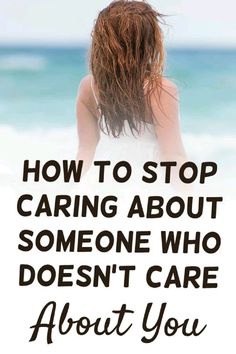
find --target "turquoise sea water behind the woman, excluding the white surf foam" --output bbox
[0,47,236,135]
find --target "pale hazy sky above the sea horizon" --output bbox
[0,0,236,47]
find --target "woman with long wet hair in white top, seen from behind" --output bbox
[76,0,185,181]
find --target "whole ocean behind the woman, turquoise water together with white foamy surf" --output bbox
[0,47,236,195]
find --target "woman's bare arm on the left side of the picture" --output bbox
[76,75,100,173]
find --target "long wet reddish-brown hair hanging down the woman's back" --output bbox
[90,0,164,137]
